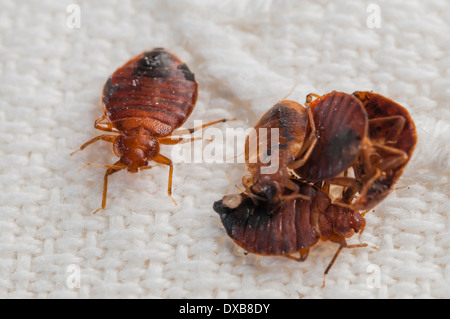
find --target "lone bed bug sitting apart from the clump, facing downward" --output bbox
[71,48,230,213]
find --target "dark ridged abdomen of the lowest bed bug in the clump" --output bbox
[215,184,322,255]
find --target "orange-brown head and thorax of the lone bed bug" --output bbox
[114,134,159,173]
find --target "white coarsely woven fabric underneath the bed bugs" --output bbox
[0,0,450,298]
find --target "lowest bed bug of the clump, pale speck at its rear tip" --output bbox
[213,180,368,285]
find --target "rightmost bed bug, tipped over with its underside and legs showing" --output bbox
[344,92,417,210]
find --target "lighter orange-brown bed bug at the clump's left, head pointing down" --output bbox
[242,100,317,206]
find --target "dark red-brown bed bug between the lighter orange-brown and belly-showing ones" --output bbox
[295,91,368,182]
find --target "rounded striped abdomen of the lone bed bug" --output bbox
[103,48,197,136]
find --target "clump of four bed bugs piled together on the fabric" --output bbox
[213,92,417,284]
